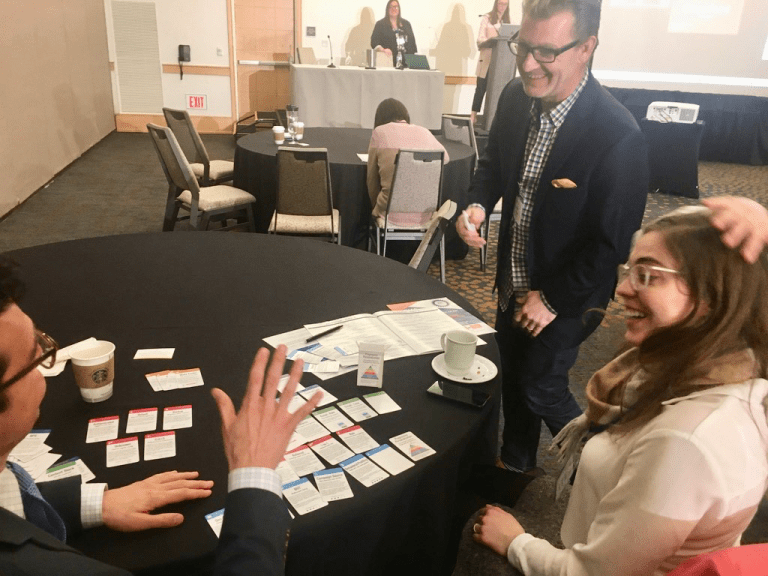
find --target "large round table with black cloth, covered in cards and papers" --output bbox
[10,232,500,576]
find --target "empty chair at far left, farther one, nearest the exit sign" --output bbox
[163,108,235,186]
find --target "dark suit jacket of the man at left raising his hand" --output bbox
[0,478,290,576]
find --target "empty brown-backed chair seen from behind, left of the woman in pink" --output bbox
[269,146,341,244]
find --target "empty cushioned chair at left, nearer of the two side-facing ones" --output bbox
[147,124,256,232]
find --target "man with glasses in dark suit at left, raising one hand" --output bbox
[0,257,321,576]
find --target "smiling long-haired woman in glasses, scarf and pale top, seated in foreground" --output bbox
[473,205,768,576]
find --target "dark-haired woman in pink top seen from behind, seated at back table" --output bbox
[368,98,448,226]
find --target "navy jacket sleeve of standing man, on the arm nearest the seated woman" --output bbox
[545,130,648,316]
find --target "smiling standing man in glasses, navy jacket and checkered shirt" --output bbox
[457,0,648,473]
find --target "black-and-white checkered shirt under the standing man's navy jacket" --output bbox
[499,72,589,314]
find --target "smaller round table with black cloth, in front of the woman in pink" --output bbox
[234,128,475,259]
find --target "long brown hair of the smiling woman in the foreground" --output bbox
[613,209,768,433]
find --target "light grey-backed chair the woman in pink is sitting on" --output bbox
[368,149,445,283]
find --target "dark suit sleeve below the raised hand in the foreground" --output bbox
[213,488,290,576]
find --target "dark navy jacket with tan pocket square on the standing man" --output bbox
[470,74,648,318]
